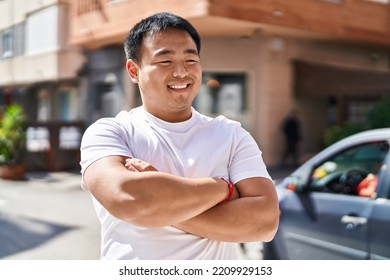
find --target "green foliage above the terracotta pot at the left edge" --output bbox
[0,104,27,165]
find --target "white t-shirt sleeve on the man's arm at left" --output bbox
[80,118,132,175]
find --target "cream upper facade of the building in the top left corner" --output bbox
[0,1,85,85]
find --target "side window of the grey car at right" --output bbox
[310,142,389,197]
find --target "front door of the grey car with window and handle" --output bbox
[280,142,388,259]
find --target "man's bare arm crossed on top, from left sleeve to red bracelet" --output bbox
[84,157,232,227]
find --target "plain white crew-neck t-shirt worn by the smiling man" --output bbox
[80,107,271,260]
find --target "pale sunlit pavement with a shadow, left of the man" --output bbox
[0,166,290,260]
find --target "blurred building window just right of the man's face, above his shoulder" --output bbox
[194,73,247,119]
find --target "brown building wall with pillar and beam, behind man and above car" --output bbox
[193,36,388,166]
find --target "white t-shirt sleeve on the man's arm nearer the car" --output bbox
[229,127,272,184]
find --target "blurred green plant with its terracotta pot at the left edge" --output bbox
[0,104,27,180]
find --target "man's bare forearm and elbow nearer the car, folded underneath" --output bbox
[174,178,279,242]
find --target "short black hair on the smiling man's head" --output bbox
[124,13,200,62]
